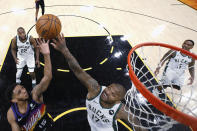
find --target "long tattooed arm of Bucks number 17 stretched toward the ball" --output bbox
[51,34,100,97]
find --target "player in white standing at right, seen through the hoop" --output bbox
[155,40,195,90]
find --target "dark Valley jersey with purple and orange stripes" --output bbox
[11,99,53,131]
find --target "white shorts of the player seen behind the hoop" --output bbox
[161,68,185,86]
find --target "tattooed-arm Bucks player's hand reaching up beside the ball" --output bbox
[51,33,67,53]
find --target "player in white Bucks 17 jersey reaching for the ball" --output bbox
[51,34,144,131]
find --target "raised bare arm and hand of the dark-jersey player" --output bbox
[32,39,52,103]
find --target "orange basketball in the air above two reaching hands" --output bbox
[36,14,62,40]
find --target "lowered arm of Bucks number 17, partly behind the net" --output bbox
[116,104,147,131]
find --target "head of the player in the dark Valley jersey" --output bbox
[6,83,29,103]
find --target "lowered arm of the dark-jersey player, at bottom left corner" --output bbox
[7,108,21,131]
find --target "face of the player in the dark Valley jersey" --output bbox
[13,85,29,101]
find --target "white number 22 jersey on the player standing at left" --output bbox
[16,35,34,58]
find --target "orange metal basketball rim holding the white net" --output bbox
[127,43,197,131]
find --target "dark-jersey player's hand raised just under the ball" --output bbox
[36,38,50,55]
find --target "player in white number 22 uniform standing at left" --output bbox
[11,27,40,87]
